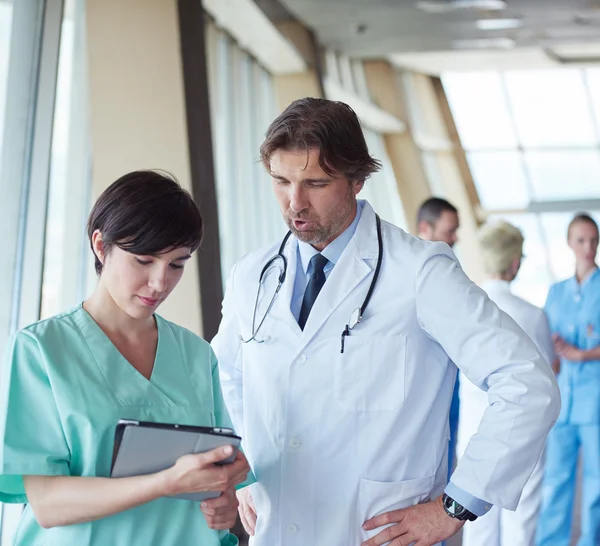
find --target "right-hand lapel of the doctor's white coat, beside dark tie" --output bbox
[301,203,378,345]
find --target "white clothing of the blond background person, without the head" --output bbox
[457,280,554,546]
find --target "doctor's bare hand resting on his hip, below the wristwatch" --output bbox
[362,496,465,546]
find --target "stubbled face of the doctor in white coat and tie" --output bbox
[270,149,363,251]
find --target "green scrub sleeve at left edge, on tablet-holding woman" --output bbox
[0,331,70,503]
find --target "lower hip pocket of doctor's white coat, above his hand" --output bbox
[357,476,435,544]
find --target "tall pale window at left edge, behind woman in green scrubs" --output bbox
[0,0,89,536]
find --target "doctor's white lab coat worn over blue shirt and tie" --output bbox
[213,203,559,546]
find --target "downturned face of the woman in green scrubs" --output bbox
[94,234,191,319]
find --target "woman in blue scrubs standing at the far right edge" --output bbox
[537,214,600,546]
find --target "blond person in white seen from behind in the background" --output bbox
[458,222,554,546]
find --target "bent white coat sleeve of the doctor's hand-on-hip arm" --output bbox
[415,243,560,510]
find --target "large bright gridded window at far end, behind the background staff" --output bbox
[443,69,600,305]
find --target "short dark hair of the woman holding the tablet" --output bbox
[87,171,203,275]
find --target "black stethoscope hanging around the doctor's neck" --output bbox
[240,214,383,353]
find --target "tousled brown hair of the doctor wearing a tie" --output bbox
[260,98,381,182]
